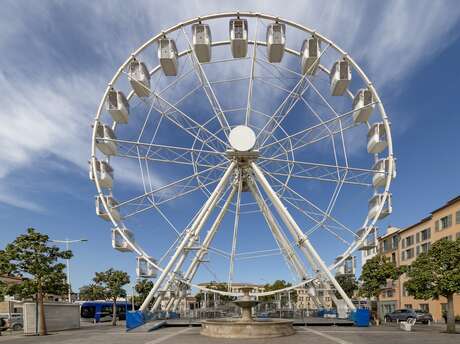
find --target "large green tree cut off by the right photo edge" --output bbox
[404,238,460,333]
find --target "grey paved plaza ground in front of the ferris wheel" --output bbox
[0,324,460,344]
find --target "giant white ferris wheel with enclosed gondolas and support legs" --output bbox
[90,12,395,311]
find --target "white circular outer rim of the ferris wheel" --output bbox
[91,11,394,296]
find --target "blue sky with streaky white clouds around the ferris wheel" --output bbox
[0,0,460,289]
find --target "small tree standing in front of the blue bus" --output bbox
[93,268,129,326]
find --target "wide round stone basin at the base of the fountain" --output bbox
[201,319,295,338]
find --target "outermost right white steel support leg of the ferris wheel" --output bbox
[251,162,356,310]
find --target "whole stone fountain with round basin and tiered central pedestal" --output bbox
[201,287,295,338]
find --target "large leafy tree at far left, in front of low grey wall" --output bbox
[0,228,72,335]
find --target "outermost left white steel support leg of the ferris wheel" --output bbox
[140,161,236,311]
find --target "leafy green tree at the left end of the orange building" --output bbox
[359,254,404,322]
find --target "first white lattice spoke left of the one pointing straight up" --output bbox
[182,28,230,138]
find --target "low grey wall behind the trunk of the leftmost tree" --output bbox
[23,302,80,335]
